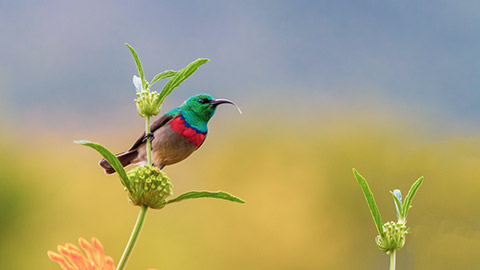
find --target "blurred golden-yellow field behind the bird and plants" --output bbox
[0,100,480,269]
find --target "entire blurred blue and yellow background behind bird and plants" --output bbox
[0,0,480,270]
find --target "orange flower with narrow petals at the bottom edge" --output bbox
[48,237,115,270]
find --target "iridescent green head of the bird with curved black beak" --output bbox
[180,94,238,132]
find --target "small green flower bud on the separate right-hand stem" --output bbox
[375,221,410,254]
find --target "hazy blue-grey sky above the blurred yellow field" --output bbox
[0,1,480,127]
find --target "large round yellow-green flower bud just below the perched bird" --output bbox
[125,165,173,209]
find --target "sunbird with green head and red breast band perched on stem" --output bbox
[99,94,242,174]
